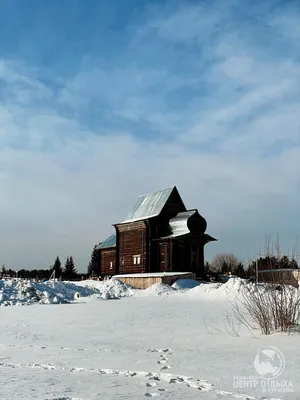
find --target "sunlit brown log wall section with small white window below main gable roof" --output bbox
[116,221,149,274]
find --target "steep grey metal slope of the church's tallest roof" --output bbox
[122,186,175,223]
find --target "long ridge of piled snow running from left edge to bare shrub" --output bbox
[0,277,260,306]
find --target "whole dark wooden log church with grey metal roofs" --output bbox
[96,186,216,279]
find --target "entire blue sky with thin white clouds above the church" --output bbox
[0,0,300,271]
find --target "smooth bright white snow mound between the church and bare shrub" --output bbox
[189,277,249,300]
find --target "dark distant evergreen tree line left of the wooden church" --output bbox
[0,256,83,280]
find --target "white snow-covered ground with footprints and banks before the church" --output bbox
[0,279,300,400]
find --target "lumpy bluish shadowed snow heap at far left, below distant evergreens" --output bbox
[0,279,98,306]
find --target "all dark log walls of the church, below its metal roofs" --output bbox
[100,233,204,277]
